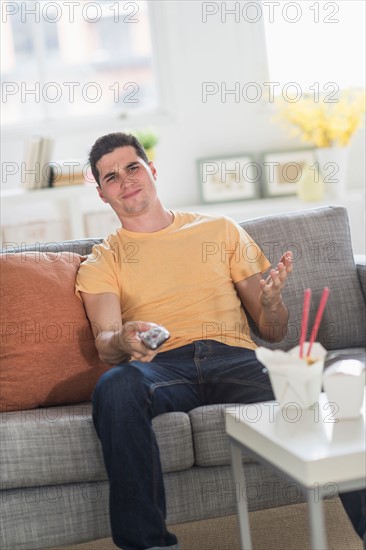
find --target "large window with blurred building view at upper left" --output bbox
[1,0,158,124]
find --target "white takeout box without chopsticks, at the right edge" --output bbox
[323,359,366,419]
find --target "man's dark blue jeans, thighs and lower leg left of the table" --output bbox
[93,340,274,550]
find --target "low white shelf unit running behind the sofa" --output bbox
[1,185,366,254]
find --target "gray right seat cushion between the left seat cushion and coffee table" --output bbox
[189,403,255,466]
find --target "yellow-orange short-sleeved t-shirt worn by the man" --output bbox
[76,212,270,351]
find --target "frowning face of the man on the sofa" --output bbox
[97,146,157,219]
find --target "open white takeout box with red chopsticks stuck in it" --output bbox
[255,342,327,409]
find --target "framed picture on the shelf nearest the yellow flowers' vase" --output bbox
[261,148,315,198]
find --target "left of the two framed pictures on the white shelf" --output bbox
[197,153,261,203]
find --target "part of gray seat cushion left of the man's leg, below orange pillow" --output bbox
[0,403,107,489]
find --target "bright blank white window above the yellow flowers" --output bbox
[262,0,366,94]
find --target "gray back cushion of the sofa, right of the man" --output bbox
[241,207,366,350]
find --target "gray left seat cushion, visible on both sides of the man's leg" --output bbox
[0,403,194,489]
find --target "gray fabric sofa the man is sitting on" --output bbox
[0,207,366,550]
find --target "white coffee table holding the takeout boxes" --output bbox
[226,393,366,550]
